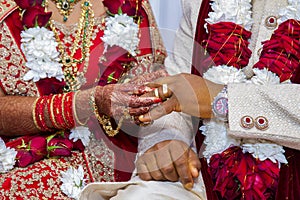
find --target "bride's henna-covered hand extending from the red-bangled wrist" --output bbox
[95,83,161,119]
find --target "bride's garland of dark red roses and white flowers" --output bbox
[0,0,141,199]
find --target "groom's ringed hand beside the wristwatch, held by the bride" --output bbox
[139,73,223,122]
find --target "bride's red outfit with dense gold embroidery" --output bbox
[0,0,166,199]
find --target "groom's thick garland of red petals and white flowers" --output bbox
[200,0,300,199]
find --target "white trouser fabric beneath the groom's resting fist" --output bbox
[80,173,206,200]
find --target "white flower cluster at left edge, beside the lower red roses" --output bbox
[0,138,17,173]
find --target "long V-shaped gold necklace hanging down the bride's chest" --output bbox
[50,0,94,92]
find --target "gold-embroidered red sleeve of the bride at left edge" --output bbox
[0,22,38,96]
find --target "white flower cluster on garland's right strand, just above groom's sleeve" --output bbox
[251,68,280,85]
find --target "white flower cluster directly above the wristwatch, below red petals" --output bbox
[203,65,246,85]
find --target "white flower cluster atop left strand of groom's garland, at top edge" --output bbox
[206,0,253,30]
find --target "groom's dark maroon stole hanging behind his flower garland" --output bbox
[192,0,300,200]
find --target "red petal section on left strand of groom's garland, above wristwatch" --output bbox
[202,22,251,69]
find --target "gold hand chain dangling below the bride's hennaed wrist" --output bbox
[90,87,125,137]
